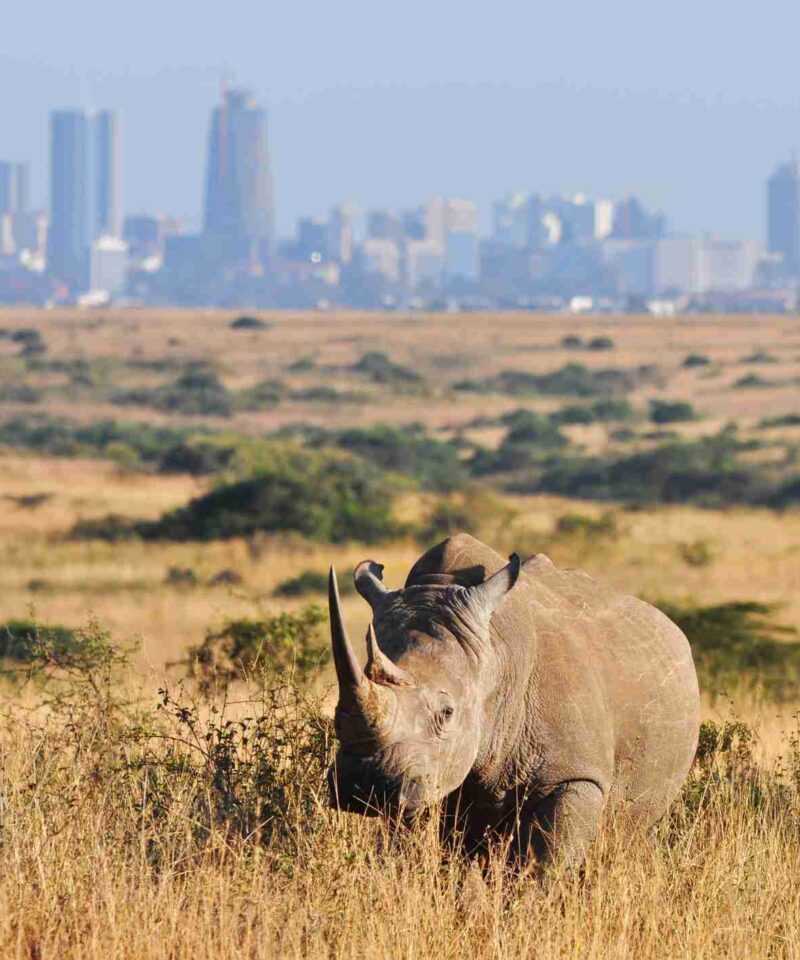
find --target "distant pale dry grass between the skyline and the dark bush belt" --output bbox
[0,309,800,433]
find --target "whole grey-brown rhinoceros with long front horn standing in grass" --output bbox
[328,534,700,866]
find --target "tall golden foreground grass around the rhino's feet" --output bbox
[0,644,800,960]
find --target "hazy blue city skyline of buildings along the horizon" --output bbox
[0,87,800,312]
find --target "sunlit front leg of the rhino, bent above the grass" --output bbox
[520,780,605,870]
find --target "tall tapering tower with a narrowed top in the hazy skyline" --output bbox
[204,89,274,266]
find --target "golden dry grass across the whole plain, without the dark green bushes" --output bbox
[0,311,800,960]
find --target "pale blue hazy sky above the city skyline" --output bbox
[0,0,800,239]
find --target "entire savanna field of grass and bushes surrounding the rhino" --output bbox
[0,310,800,960]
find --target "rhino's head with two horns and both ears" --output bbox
[328,554,520,815]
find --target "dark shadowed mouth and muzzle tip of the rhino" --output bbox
[328,750,424,817]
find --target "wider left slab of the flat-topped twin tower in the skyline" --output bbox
[47,110,92,292]
